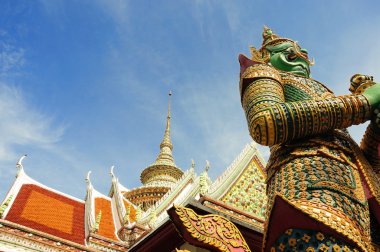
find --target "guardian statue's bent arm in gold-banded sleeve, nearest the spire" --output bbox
[241,66,371,146]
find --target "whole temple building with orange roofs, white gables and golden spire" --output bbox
[0,93,267,251]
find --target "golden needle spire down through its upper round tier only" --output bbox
[141,92,183,187]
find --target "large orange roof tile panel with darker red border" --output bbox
[5,184,85,244]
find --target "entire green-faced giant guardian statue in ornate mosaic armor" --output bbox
[239,27,380,251]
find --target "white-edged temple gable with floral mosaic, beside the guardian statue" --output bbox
[135,142,266,229]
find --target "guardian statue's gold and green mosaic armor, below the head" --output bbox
[240,62,380,251]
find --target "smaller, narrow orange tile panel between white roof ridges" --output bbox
[95,198,118,240]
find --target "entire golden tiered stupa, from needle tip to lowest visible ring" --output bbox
[124,92,183,211]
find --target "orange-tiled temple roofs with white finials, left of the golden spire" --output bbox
[0,164,136,250]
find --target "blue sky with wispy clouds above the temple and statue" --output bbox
[0,0,380,198]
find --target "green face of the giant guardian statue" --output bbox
[266,42,310,77]
